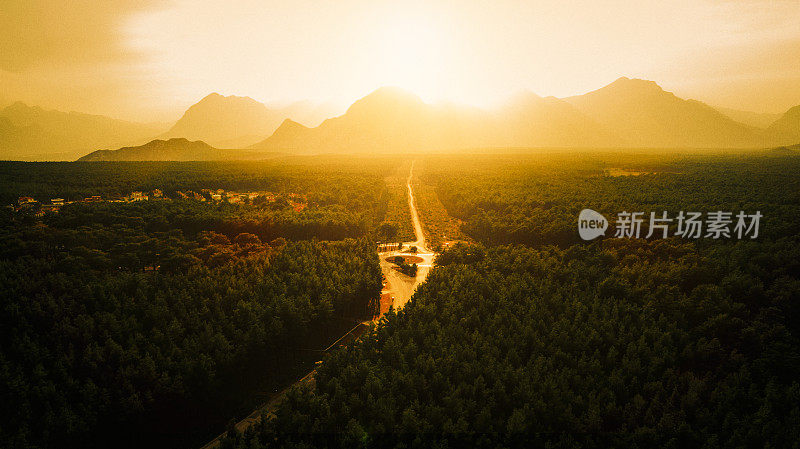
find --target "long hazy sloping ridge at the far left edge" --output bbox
[0,102,163,160]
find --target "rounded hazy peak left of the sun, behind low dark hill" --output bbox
[159,93,336,148]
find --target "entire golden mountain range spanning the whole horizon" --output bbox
[0,77,800,159]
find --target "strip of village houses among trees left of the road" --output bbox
[8,189,308,217]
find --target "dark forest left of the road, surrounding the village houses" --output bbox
[0,156,391,448]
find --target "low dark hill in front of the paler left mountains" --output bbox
[78,138,267,162]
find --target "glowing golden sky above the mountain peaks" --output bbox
[0,0,800,122]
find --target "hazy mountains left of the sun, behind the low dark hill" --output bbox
[0,93,332,160]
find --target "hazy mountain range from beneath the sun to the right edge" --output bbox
[252,78,800,153]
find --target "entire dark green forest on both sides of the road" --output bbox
[0,153,800,449]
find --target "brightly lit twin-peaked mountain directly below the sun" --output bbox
[252,87,620,153]
